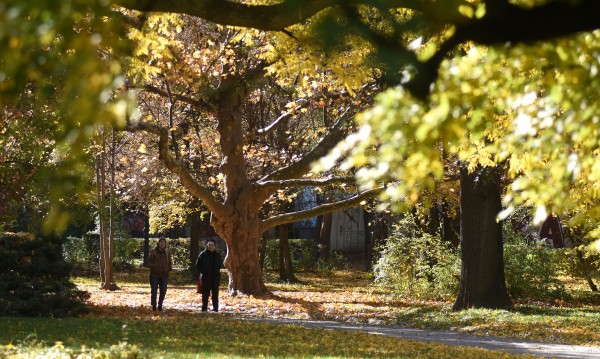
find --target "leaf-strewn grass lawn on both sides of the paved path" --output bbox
[0,271,600,358]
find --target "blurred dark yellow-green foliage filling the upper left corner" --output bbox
[0,0,134,232]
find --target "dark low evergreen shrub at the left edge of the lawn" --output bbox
[0,233,88,317]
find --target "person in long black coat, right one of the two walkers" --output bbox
[196,239,222,312]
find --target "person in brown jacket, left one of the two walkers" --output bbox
[146,238,172,310]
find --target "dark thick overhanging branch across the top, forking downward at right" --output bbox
[115,0,600,102]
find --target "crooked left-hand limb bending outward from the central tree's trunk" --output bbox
[125,121,226,214]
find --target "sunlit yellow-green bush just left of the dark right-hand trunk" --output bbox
[373,215,460,299]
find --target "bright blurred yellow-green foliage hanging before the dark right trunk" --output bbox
[323,31,600,250]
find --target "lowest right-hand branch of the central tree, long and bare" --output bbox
[260,188,383,232]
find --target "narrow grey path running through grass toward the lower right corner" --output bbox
[237,317,600,359]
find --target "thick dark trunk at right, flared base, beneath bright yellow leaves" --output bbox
[453,168,512,310]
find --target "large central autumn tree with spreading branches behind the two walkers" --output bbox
[118,16,378,294]
